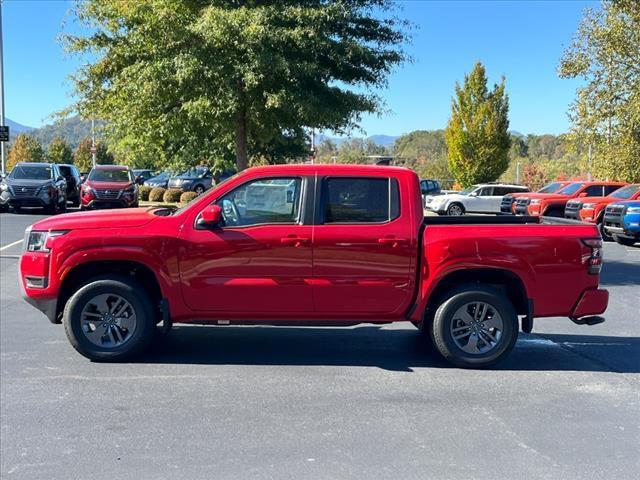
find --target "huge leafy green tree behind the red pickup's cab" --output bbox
[64,0,407,170]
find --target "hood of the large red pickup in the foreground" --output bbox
[32,208,158,230]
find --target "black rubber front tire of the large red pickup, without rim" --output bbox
[62,275,155,362]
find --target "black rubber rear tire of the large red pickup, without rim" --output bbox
[431,285,519,368]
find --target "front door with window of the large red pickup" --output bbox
[179,177,313,318]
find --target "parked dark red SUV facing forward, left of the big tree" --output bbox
[80,165,138,210]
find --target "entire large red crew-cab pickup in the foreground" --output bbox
[20,165,608,367]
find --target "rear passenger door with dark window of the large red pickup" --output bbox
[313,170,419,318]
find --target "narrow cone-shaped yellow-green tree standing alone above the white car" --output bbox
[445,62,511,187]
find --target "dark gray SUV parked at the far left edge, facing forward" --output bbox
[0,162,67,213]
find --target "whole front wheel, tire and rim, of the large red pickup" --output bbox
[63,275,155,361]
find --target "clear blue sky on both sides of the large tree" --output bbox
[3,0,598,135]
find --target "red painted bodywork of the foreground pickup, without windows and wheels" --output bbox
[20,165,606,323]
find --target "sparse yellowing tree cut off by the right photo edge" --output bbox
[559,0,640,182]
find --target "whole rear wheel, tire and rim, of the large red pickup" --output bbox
[431,285,518,368]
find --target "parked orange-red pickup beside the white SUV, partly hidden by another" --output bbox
[515,181,625,217]
